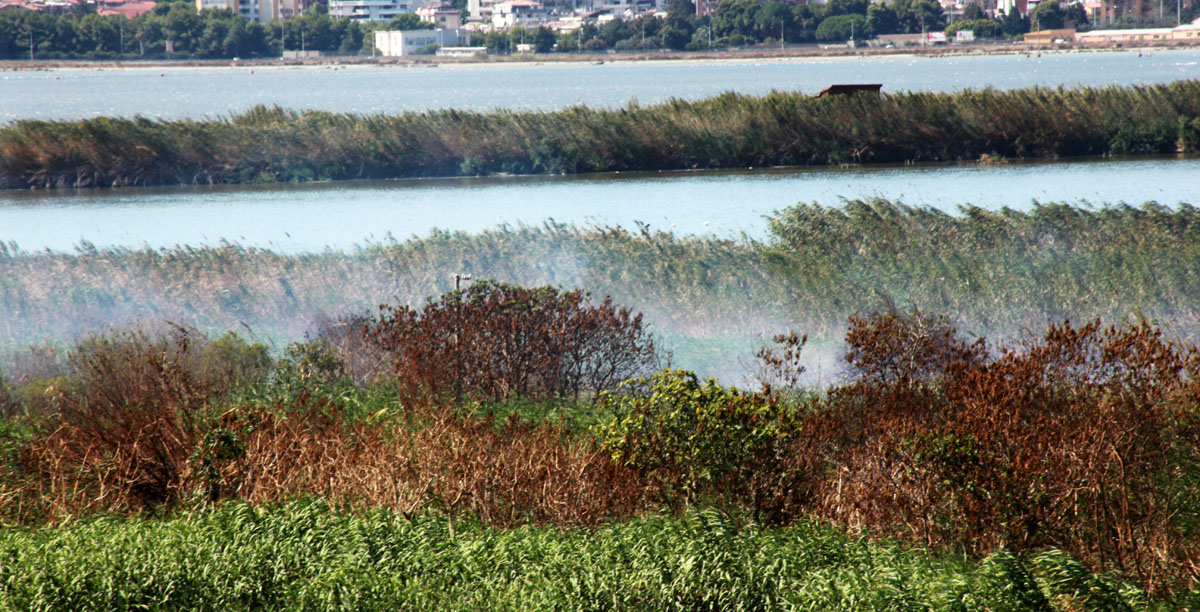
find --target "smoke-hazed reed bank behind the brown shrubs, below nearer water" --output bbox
[0,202,1200,380]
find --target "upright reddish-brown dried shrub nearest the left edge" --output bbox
[26,332,212,514]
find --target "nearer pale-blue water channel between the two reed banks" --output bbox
[0,157,1200,253]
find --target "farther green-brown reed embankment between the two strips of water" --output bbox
[7,80,1200,188]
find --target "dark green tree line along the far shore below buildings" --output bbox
[16,0,1200,59]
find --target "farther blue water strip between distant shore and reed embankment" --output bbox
[7,49,1200,124]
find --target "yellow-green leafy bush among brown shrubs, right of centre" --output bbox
[595,370,799,510]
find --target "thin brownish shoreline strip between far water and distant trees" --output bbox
[0,41,1198,72]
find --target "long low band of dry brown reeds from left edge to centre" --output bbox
[5,397,652,527]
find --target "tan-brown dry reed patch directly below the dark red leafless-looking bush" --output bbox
[228,400,648,527]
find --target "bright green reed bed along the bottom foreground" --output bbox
[0,502,1147,611]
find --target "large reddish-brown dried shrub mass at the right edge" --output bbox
[796,314,1200,590]
